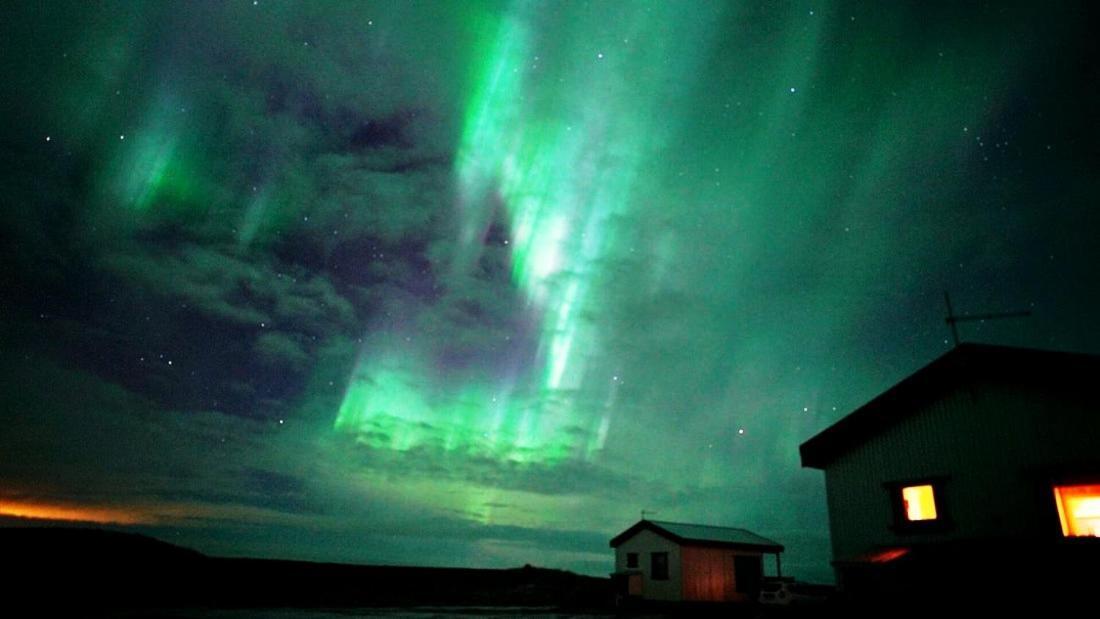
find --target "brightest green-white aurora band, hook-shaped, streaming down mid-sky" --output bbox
[336,2,710,464]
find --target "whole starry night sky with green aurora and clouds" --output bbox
[0,0,1100,581]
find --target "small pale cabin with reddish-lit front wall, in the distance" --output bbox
[611,519,783,603]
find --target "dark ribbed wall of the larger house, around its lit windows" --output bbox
[825,382,1100,559]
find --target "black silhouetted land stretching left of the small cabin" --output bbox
[0,528,612,618]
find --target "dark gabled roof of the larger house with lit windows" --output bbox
[799,344,1100,468]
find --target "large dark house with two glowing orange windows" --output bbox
[801,344,1100,597]
